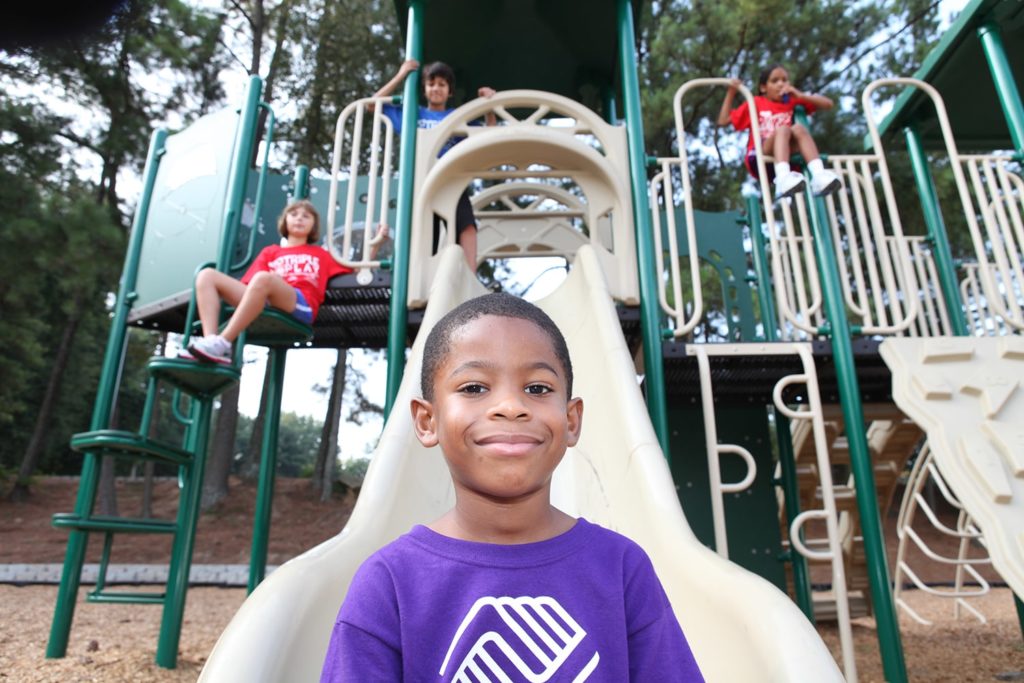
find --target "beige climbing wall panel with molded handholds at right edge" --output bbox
[880,337,1024,595]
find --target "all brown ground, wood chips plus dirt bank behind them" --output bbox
[0,478,1024,682]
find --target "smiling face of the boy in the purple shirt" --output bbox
[413,315,583,503]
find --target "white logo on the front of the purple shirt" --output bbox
[438,596,601,683]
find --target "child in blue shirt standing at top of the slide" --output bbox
[374,59,495,272]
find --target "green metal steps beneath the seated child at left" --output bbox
[47,309,312,668]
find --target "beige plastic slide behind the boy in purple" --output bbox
[200,246,843,683]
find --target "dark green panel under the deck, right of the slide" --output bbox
[669,401,786,592]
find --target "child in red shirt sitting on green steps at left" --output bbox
[181,200,388,365]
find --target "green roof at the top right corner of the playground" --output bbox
[880,0,1024,151]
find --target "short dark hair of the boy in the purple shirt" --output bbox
[420,292,572,400]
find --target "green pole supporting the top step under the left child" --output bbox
[249,346,288,593]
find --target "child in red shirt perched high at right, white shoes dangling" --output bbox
[717,65,843,199]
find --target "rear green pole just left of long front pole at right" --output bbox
[746,195,814,624]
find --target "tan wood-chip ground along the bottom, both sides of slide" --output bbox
[0,586,1024,683]
